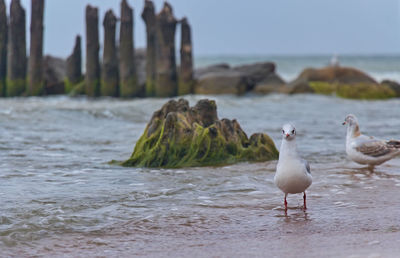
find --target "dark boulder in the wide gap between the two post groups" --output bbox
[43,56,66,95]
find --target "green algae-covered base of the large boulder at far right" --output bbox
[309,81,396,100]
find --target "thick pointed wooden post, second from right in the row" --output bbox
[155,2,178,97]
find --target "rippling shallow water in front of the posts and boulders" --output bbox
[0,95,400,257]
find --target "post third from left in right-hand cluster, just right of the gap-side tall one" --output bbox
[100,10,119,97]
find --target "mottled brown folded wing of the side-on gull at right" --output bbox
[355,139,400,158]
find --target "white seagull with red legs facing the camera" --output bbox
[274,124,312,213]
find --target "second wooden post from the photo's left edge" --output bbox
[6,0,26,96]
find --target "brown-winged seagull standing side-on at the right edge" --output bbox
[343,114,400,168]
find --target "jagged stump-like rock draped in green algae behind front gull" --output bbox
[122,99,278,168]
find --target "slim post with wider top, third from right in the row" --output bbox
[142,0,157,97]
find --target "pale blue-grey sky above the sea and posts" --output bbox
[6,0,400,57]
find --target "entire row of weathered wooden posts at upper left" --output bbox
[0,0,193,97]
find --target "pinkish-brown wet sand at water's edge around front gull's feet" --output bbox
[3,159,400,257]
